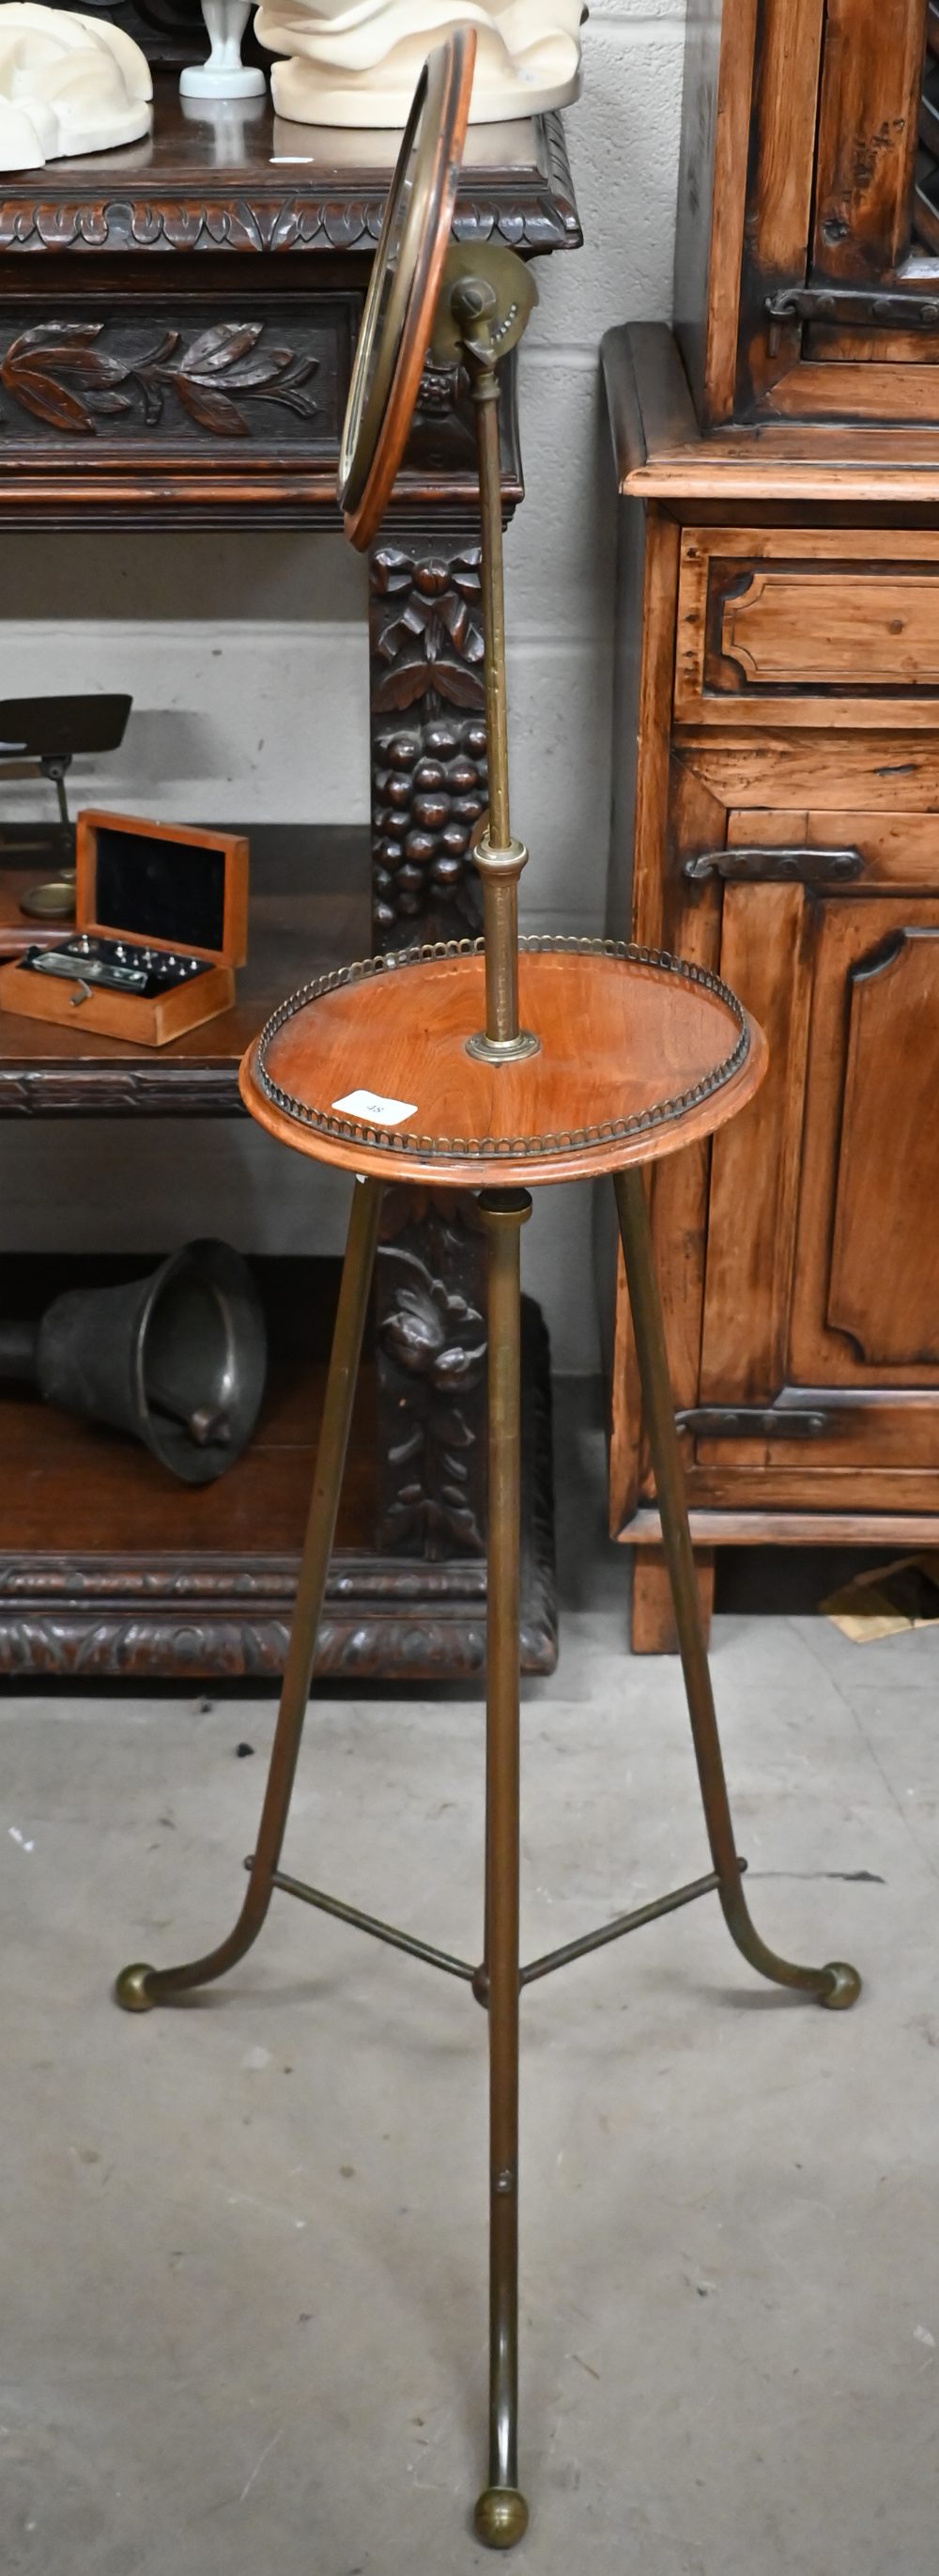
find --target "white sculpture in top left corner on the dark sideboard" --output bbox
[0,0,152,170]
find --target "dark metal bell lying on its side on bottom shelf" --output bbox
[0,1242,268,1483]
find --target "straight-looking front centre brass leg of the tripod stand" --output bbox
[473,1190,532,2551]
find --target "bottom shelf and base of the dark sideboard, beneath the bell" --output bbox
[0,1254,556,1680]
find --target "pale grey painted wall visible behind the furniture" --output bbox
[0,0,685,1371]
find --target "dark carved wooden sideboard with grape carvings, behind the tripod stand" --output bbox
[0,75,578,1677]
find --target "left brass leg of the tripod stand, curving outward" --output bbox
[115,1180,383,2012]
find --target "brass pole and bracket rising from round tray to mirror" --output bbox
[432,242,540,1063]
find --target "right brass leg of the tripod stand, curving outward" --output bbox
[612,1170,862,2012]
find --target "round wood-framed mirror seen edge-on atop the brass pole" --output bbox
[340,25,476,549]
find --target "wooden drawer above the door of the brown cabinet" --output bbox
[674,528,939,726]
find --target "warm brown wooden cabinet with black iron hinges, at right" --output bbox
[605,0,939,1649]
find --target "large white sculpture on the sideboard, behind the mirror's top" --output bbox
[254,0,581,126]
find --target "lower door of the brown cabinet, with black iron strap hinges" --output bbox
[689,812,939,1510]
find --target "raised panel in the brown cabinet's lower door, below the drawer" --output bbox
[828,923,939,1368]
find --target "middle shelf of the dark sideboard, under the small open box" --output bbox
[0,824,371,1118]
